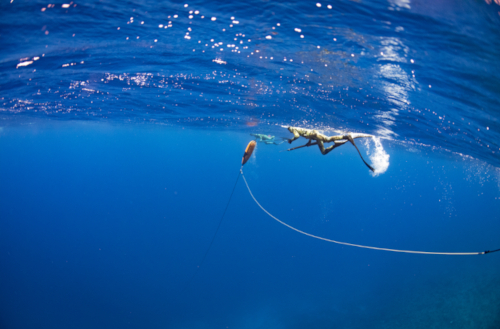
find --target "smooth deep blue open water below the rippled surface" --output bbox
[0,123,500,328]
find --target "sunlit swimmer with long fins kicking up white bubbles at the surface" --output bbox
[287,127,375,172]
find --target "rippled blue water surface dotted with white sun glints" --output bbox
[0,0,500,167]
